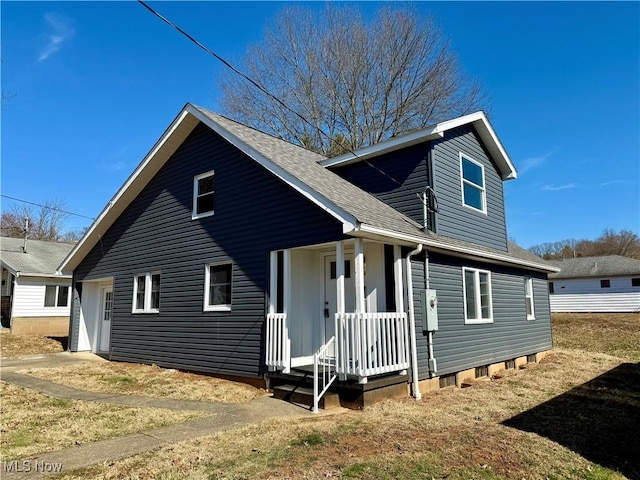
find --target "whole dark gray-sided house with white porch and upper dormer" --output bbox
[60,104,557,407]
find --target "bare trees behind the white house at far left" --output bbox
[0,200,69,241]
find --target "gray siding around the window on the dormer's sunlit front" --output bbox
[432,125,507,251]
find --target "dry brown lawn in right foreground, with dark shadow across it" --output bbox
[57,317,640,480]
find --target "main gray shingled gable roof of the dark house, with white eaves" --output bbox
[59,103,554,271]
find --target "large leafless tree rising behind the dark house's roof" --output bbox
[220,4,484,155]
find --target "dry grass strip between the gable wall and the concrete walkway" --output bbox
[20,362,266,403]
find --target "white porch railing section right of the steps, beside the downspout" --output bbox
[336,312,409,379]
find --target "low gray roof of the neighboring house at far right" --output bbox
[548,255,640,279]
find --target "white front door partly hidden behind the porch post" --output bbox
[322,254,356,345]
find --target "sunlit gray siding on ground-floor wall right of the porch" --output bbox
[412,254,552,379]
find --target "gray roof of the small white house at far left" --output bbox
[0,237,74,278]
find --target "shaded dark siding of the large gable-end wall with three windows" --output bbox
[72,125,344,376]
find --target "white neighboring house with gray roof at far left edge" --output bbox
[0,237,74,336]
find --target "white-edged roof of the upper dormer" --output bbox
[320,111,518,180]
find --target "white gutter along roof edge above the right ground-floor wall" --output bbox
[350,224,560,272]
